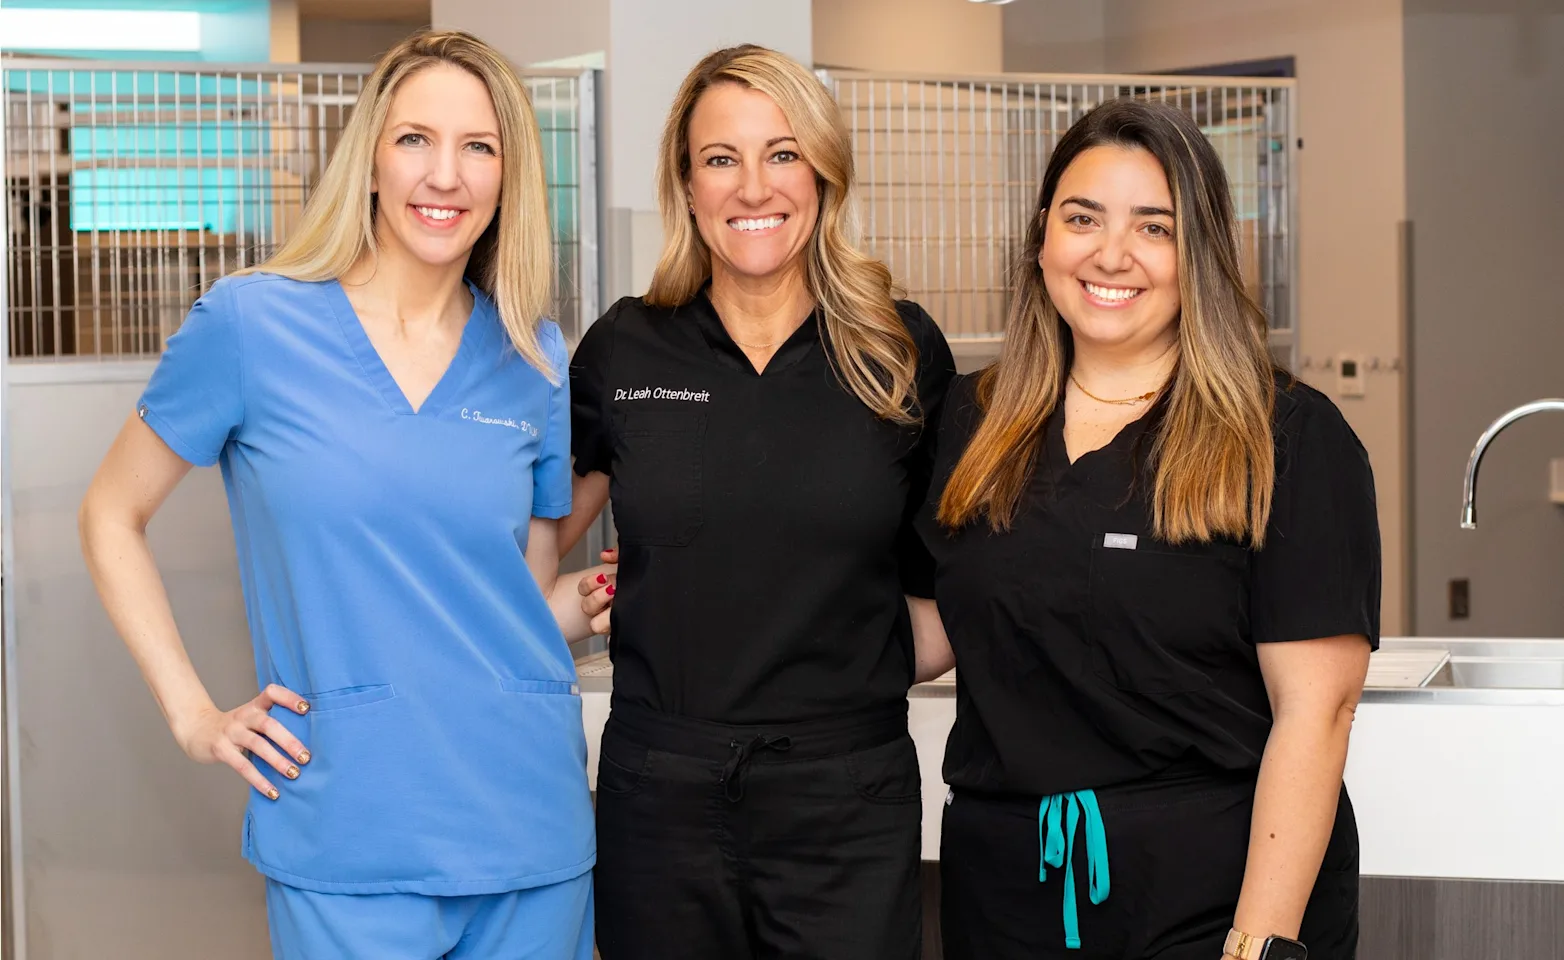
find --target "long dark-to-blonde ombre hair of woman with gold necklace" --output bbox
[938,99,1276,547]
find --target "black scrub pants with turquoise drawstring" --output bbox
[940,774,1358,960]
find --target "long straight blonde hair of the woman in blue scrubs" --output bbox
[236,31,560,381]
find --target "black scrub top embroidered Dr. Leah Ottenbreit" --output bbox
[571,291,956,724]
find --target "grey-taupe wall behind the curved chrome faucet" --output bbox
[1406,0,1564,636]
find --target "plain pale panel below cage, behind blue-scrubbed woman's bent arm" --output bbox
[6,361,271,960]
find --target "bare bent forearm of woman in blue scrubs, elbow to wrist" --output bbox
[81,514,216,743]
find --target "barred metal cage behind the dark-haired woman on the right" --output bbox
[820,70,1298,366]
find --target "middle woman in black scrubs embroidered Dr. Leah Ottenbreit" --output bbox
[561,47,954,960]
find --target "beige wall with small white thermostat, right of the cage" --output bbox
[1104,0,1406,633]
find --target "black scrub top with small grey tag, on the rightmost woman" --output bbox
[918,374,1379,796]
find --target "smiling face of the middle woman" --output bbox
[685,83,820,289]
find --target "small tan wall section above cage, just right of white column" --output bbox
[813,0,1004,73]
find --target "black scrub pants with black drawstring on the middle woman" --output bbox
[596,704,923,960]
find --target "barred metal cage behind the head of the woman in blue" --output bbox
[0,56,599,360]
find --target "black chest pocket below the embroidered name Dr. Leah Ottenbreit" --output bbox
[612,410,705,547]
